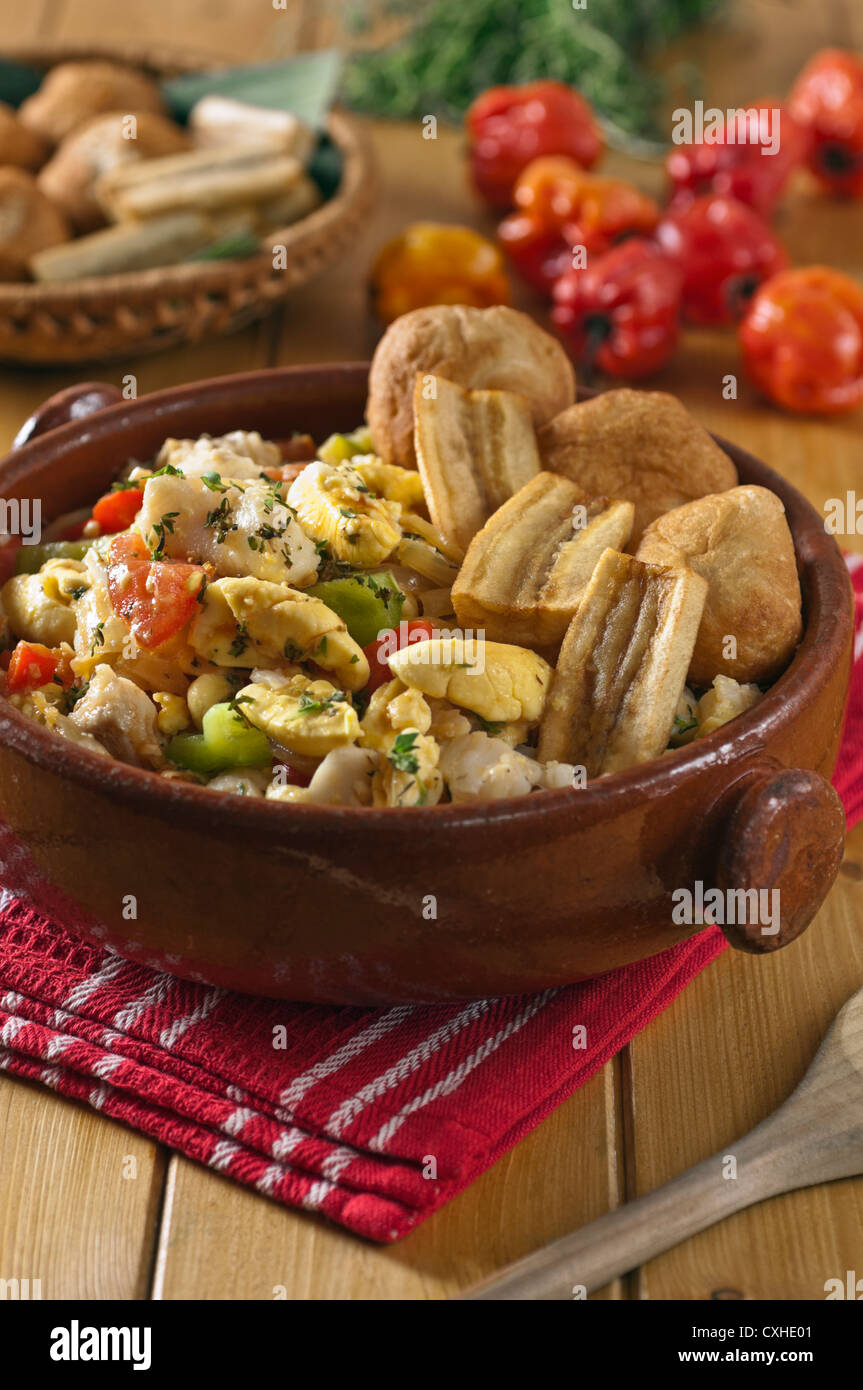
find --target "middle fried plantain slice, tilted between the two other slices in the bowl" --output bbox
[453,473,635,646]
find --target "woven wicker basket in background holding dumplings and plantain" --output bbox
[0,43,375,366]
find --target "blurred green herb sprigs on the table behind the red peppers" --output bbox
[342,0,727,145]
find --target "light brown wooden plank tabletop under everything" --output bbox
[0,0,863,1300]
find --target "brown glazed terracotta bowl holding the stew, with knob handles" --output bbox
[0,364,852,1005]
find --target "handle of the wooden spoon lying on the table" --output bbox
[461,1112,794,1301]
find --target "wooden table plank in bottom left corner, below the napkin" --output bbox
[0,1076,165,1298]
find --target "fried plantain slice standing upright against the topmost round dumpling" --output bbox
[414,373,539,550]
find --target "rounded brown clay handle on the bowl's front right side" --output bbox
[716,759,845,955]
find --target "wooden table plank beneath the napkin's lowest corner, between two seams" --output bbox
[153,1063,623,1300]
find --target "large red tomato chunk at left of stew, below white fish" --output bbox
[108,532,204,649]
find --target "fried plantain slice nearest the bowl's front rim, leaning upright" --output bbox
[539,549,707,777]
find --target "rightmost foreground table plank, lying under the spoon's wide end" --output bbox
[631,826,863,1300]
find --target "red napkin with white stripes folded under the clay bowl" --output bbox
[0,557,863,1241]
